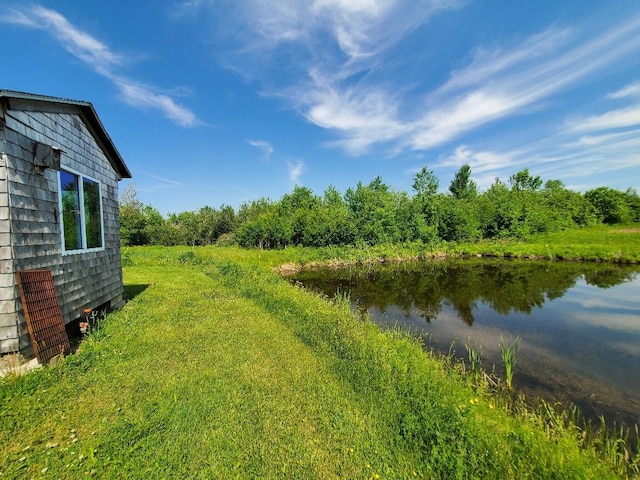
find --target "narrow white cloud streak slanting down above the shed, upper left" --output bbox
[0,5,201,127]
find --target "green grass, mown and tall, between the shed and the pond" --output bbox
[0,230,637,479]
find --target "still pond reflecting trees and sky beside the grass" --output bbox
[293,260,640,434]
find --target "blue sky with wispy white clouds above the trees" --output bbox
[0,0,640,214]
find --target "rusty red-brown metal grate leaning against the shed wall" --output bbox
[16,270,71,363]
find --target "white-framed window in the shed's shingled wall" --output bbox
[59,167,104,253]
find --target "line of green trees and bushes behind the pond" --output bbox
[120,165,640,248]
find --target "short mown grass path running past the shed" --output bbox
[0,253,418,478]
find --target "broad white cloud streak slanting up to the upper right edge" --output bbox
[410,17,640,149]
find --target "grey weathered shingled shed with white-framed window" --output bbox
[0,90,131,353]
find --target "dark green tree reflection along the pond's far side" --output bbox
[294,260,638,325]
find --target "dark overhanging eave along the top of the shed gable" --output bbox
[0,90,131,179]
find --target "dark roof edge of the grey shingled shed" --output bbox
[0,90,131,178]
